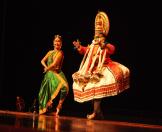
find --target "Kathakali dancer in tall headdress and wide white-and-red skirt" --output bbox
[72,11,130,119]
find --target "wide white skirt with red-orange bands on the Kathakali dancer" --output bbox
[72,61,130,103]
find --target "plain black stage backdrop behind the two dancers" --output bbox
[0,0,162,116]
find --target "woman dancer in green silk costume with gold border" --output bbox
[38,35,69,116]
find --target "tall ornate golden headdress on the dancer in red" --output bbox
[95,11,110,36]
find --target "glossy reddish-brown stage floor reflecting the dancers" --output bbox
[0,110,162,132]
